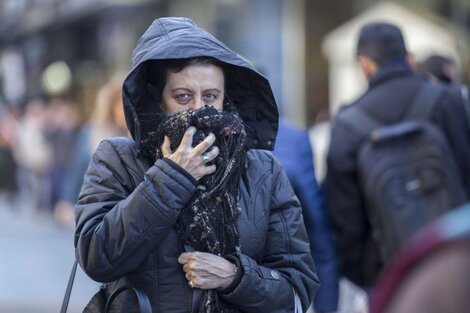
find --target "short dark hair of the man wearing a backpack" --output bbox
[357,22,408,66]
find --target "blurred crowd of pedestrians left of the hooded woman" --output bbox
[0,75,127,224]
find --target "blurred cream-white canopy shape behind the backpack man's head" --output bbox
[322,2,459,116]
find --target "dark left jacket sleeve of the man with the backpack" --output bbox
[323,122,368,286]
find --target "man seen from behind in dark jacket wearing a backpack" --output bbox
[323,23,470,288]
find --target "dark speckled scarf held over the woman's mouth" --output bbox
[142,106,246,313]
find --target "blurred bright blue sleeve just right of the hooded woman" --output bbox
[289,132,339,312]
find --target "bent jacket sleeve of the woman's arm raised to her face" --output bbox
[75,141,196,282]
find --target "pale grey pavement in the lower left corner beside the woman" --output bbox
[0,195,98,313]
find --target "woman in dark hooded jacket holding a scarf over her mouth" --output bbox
[75,18,318,313]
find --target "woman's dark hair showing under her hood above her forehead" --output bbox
[145,56,226,108]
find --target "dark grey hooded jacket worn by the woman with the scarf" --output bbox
[75,18,318,313]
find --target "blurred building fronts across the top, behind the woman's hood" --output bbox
[0,0,470,127]
